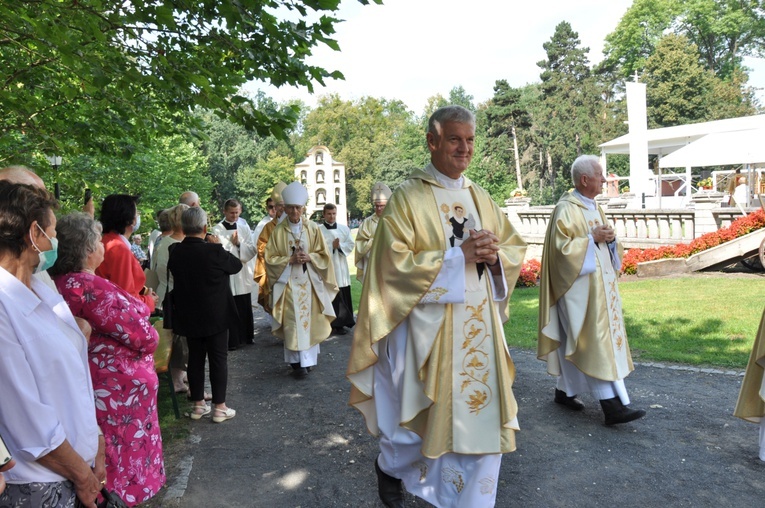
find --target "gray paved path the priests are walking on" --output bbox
[151,308,765,508]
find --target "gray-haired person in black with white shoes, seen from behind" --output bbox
[167,207,242,423]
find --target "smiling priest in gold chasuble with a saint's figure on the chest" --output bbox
[347,106,526,508]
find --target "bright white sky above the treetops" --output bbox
[247,0,765,114]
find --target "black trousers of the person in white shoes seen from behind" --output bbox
[186,330,228,404]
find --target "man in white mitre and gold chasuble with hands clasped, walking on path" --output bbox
[265,182,337,378]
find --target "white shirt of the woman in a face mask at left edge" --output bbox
[0,268,98,483]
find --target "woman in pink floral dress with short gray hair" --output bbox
[50,213,165,506]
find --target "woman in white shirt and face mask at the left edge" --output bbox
[0,181,106,508]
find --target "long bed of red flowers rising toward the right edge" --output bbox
[622,209,765,274]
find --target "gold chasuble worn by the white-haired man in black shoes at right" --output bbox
[537,193,634,380]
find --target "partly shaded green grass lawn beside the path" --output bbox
[351,277,765,369]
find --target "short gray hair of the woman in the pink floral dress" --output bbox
[49,212,101,276]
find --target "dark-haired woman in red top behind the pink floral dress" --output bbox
[96,194,158,312]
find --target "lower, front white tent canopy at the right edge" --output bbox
[659,128,765,168]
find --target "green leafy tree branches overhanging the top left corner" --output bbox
[0,0,381,161]
